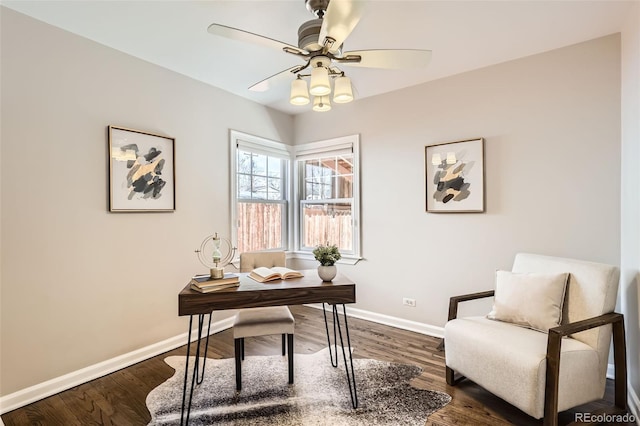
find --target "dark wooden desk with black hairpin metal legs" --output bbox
[178,269,358,425]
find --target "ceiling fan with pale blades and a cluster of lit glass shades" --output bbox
[207,0,431,111]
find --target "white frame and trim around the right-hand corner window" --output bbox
[291,135,362,264]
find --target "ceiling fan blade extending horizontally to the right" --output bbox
[336,49,431,69]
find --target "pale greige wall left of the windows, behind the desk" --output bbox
[0,8,293,395]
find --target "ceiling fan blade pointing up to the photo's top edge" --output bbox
[318,0,364,53]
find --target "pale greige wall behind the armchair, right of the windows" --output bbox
[295,35,620,326]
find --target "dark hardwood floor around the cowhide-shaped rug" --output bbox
[2,306,633,426]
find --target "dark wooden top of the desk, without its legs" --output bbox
[178,269,356,316]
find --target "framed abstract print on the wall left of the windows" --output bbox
[107,126,176,212]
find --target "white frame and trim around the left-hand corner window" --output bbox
[229,130,292,255]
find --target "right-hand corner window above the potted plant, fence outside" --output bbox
[295,136,360,258]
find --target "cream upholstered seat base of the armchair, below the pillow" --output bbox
[445,317,605,419]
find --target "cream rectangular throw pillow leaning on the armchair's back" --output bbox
[487,271,569,332]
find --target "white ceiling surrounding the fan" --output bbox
[0,0,637,114]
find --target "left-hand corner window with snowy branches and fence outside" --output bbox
[231,131,290,253]
